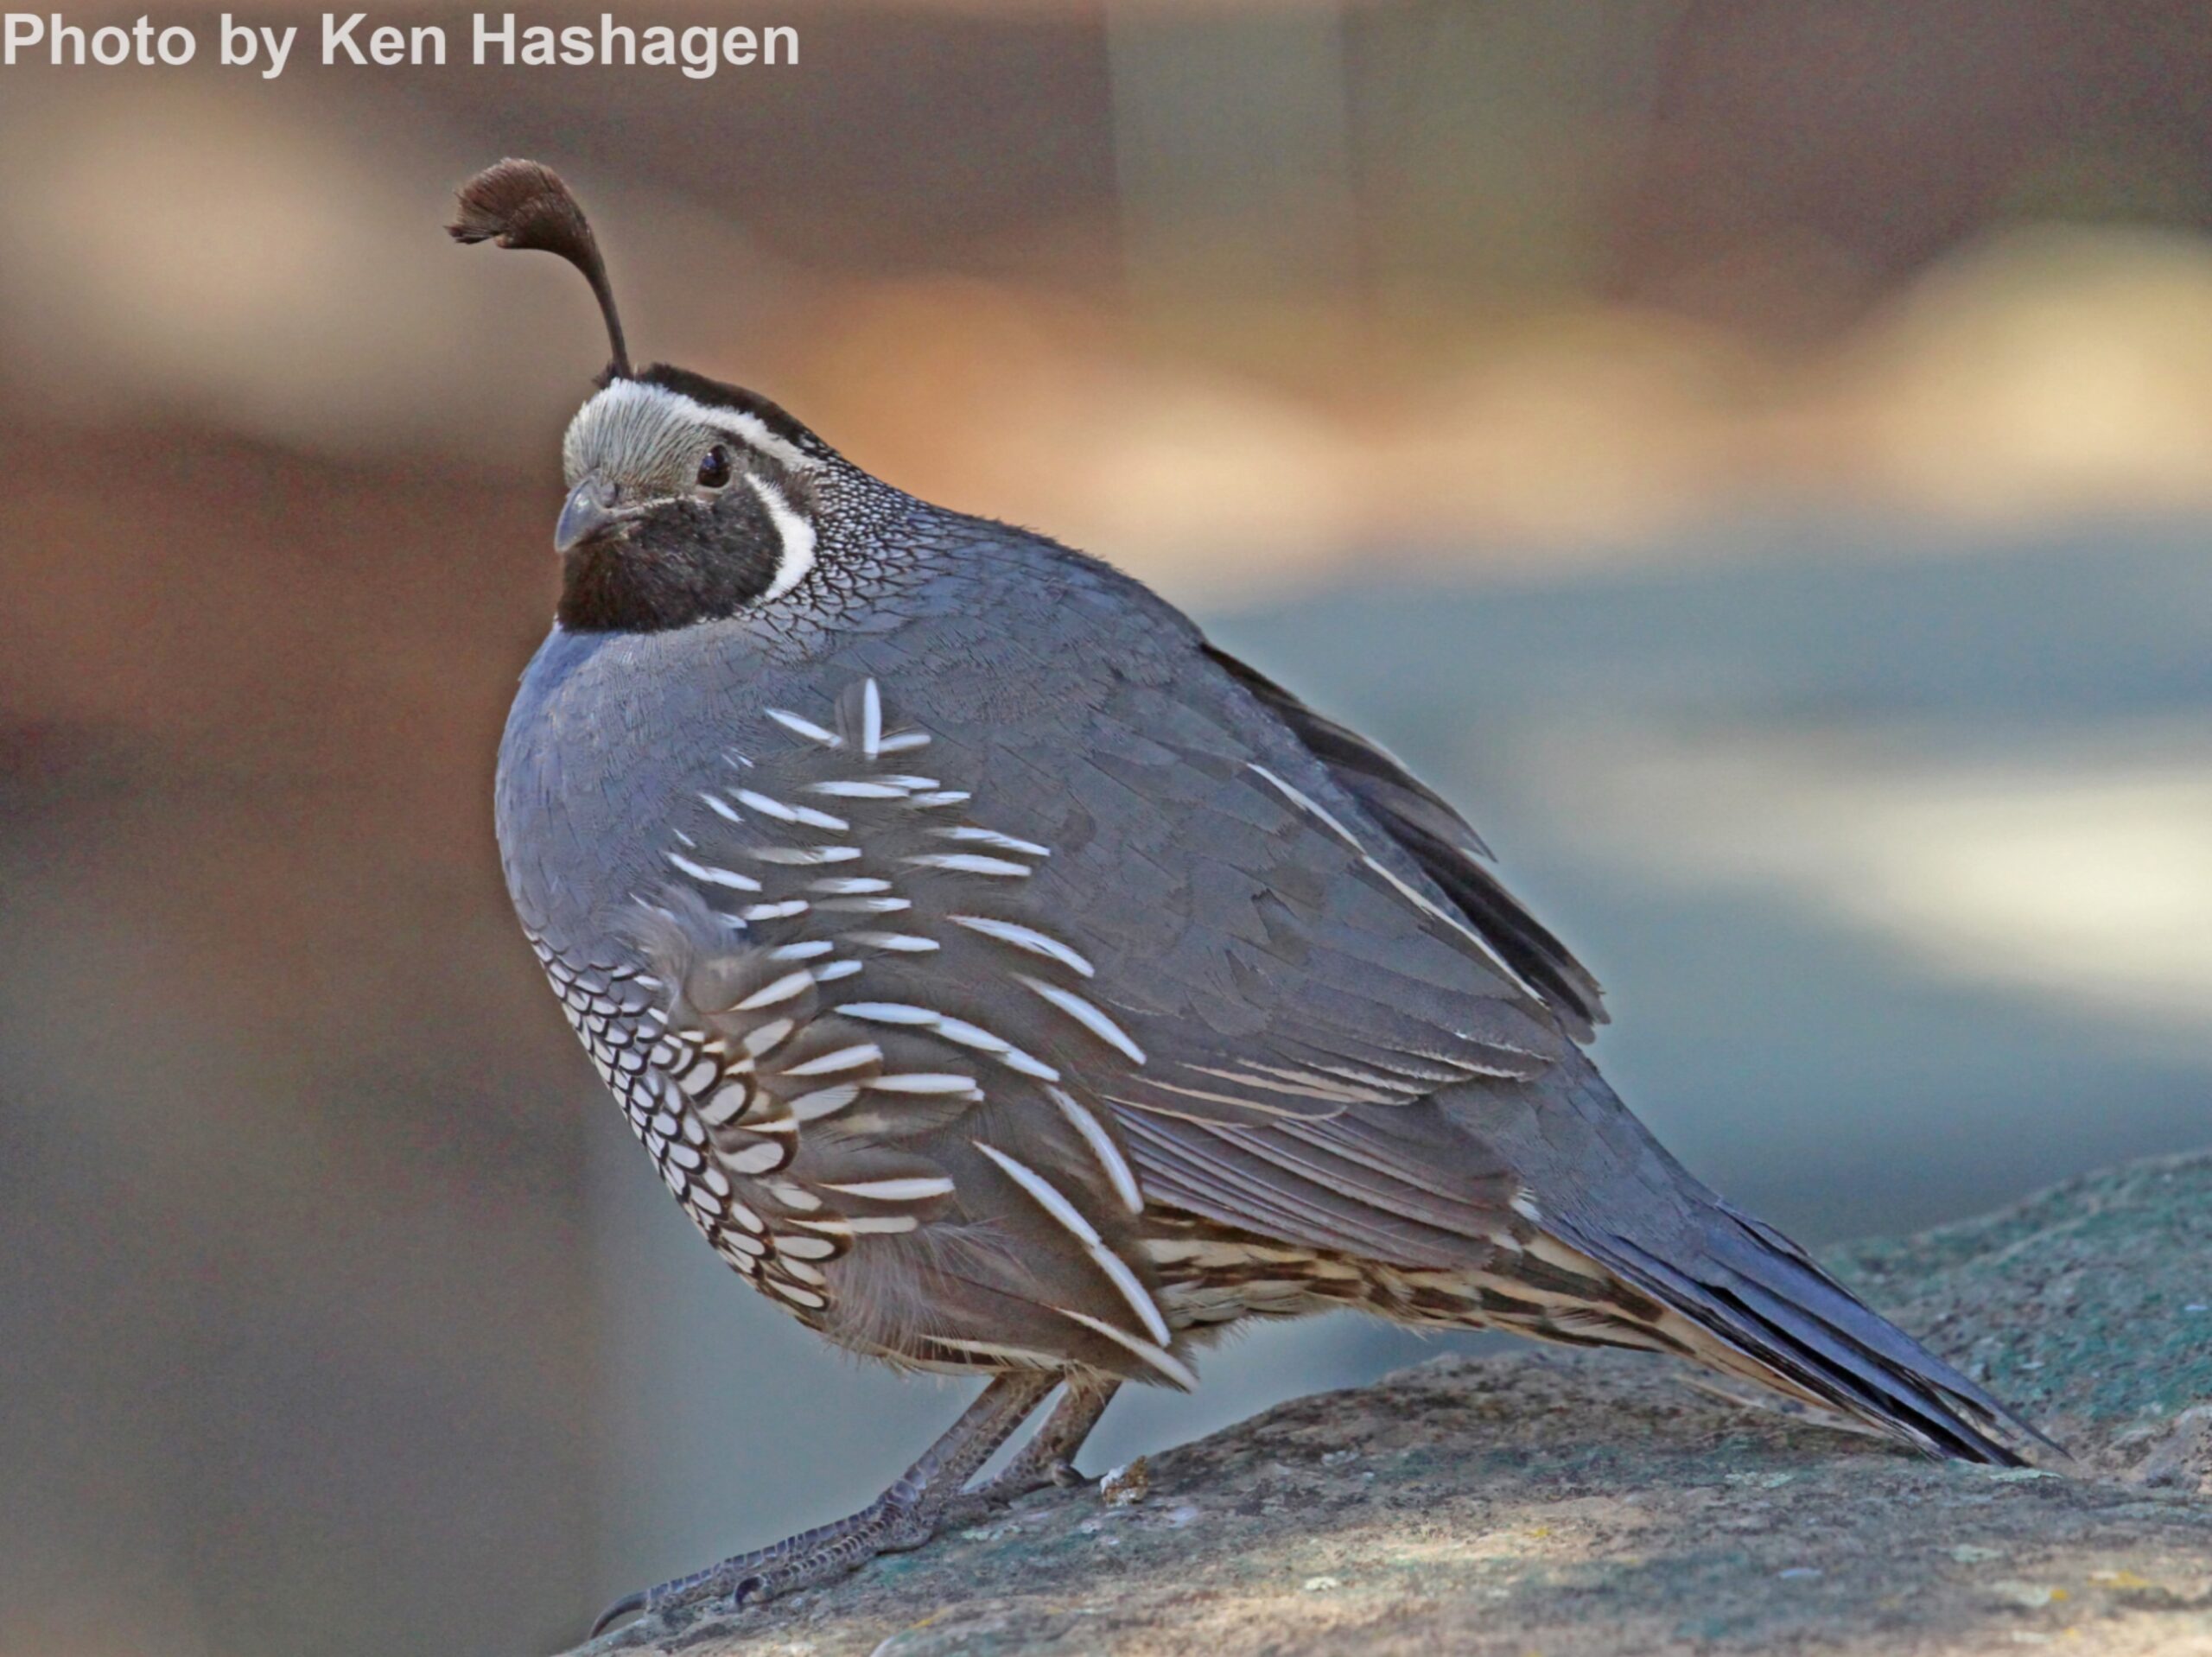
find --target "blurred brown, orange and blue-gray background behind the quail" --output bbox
[0,0,2212,1657]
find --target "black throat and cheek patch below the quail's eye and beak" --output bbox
[560,482,785,632]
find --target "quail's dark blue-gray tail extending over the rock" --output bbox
[1557,1199,2063,1467]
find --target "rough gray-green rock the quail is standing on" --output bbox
[566,1155,2212,1657]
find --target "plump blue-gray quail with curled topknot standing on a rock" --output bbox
[449,159,2049,1633]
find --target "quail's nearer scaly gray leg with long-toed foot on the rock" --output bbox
[591,1369,1058,1637]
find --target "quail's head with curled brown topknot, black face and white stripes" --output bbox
[449,162,836,632]
